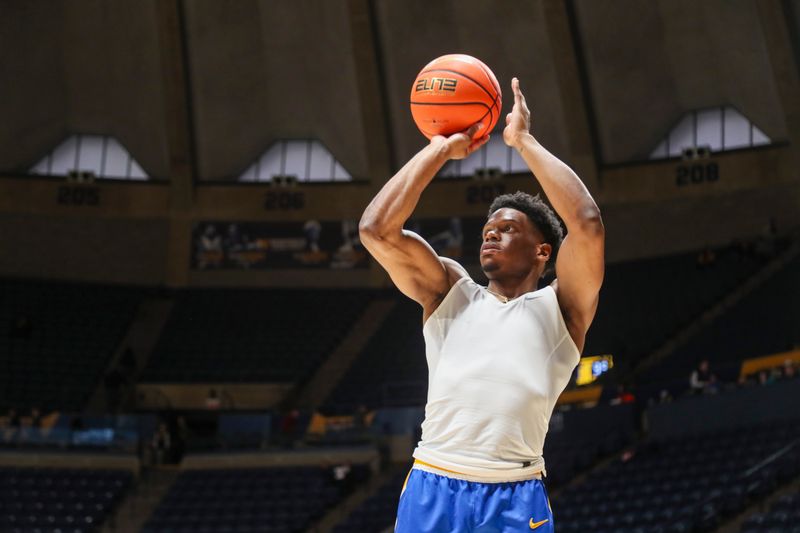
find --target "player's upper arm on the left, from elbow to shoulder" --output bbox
[361,230,450,309]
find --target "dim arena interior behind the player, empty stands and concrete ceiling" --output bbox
[0,0,800,533]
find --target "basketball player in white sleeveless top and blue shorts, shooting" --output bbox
[359,78,604,533]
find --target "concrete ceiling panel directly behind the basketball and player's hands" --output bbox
[376,0,566,168]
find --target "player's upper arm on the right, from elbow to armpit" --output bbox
[556,227,605,333]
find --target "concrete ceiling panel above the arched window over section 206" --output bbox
[186,0,371,180]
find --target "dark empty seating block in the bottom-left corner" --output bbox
[0,468,132,533]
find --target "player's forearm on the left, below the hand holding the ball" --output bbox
[358,139,448,236]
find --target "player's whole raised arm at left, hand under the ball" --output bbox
[358,125,488,318]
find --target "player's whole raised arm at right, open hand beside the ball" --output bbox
[503,78,605,347]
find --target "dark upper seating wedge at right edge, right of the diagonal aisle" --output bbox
[645,254,800,386]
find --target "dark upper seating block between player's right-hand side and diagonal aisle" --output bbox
[584,244,760,365]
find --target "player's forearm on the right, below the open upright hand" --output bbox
[516,134,602,231]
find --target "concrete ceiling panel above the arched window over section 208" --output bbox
[575,0,787,163]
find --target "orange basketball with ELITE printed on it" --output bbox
[411,54,502,139]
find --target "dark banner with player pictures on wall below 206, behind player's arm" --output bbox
[191,217,486,270]
